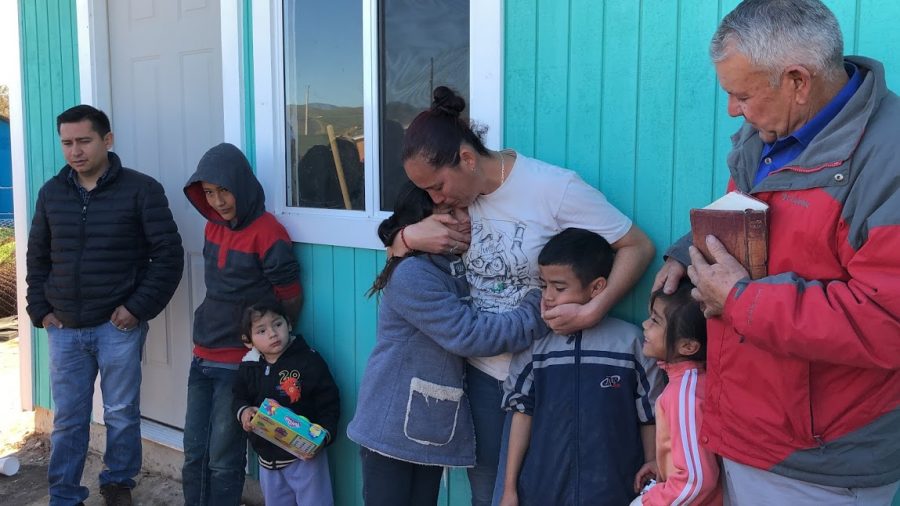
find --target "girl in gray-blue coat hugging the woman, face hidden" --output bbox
[347,184,548,505]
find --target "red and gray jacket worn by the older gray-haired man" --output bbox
[668,57,900,487]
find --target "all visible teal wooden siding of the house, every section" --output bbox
[20,0,900,506]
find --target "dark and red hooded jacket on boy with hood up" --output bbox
[184,143,300,364]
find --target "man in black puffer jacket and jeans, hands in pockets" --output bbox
[27,105,184,505]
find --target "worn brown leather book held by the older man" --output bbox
[691,192,769,279]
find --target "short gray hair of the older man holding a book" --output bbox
[709,0,846,86]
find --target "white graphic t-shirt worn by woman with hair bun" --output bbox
[463,154,631,380]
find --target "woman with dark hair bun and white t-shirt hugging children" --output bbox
[392,86,655,505]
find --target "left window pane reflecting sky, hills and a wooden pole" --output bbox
[283,0,365,210]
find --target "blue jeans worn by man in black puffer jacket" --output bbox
[47,322,148,506]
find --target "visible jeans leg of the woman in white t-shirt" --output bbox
[466,364,506,506]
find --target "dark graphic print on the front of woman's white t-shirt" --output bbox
[466,219,534,313]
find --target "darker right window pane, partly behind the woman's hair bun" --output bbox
[378,0,469,211]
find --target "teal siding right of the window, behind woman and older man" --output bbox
[504,0,900,322]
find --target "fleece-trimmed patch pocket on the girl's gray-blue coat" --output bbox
[403,377,463,446]
